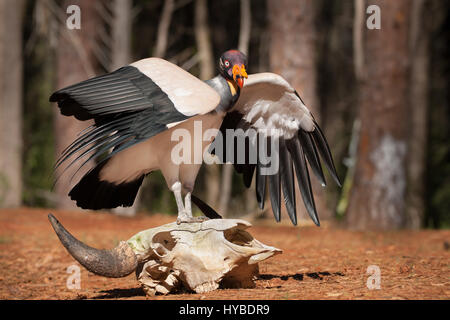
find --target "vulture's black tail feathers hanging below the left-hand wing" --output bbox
[69,161,145,210]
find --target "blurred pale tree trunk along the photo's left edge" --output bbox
[0,0,25,207]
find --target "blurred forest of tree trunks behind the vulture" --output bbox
[0,0,450,229]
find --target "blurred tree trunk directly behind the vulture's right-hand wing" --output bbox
[267,0,331,219]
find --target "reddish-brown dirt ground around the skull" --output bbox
[0,208,450,300]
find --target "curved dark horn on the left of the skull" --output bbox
[48,213,138,278]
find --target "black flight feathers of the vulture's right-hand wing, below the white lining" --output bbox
[212,111,337,225]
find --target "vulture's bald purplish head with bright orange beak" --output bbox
[219,50,248,89]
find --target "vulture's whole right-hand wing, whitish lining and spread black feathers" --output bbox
[211,73,340,225]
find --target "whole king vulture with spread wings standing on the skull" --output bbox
[50,50,340,225]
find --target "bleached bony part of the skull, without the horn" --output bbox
[127,219,281,295]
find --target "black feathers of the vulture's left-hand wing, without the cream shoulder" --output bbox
[50,66,189,179]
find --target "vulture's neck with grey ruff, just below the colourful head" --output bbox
[205,75,241,113]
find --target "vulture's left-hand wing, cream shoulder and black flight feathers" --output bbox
[50,58,220,180]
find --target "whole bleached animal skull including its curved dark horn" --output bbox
[48,214,281,295]
